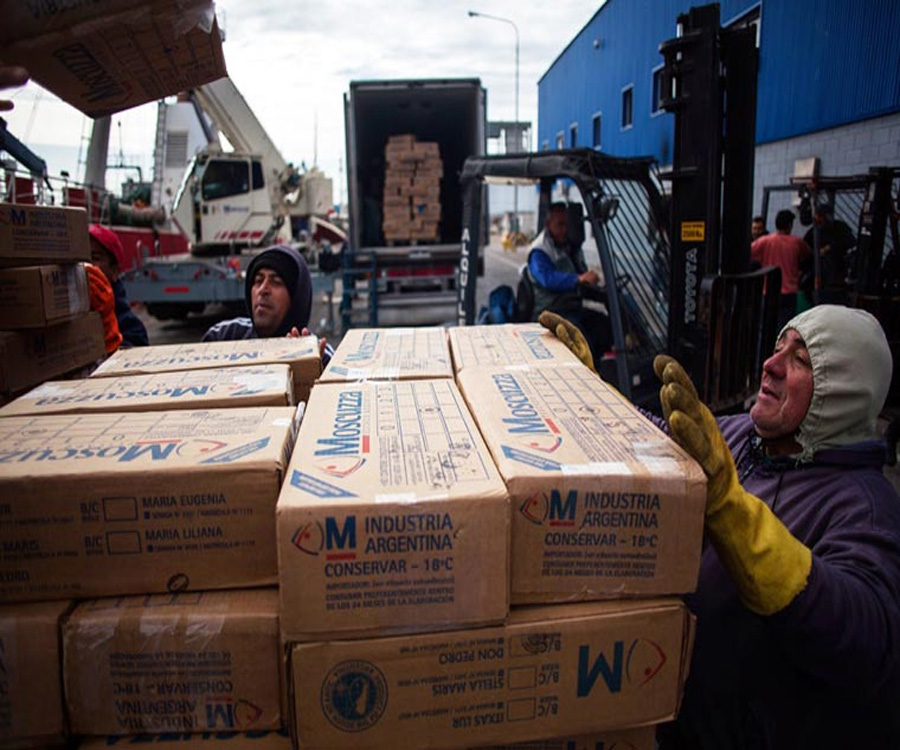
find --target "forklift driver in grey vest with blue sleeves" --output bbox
[524,202,612,362]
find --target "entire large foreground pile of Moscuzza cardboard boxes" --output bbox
[0,325,704,750]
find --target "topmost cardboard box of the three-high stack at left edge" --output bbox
[0,203,91,267]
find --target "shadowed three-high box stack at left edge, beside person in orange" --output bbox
[0,203,106,403]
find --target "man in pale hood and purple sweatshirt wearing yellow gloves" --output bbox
[543,305,900,750]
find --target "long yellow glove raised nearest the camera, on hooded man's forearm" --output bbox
[653,354,812,615]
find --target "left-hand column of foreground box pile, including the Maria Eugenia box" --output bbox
[0,337,321,747]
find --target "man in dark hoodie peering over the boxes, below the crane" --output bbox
[203,245,333,364]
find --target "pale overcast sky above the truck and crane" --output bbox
[5,0,602,200]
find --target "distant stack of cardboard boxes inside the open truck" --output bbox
[382,135,444,244]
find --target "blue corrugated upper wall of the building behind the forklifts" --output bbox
[537,0,900,163]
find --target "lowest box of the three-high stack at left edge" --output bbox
[0,312,106,395]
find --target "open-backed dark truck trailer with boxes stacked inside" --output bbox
[341,78,487,330]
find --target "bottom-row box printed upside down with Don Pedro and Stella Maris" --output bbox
[290,599,693,749]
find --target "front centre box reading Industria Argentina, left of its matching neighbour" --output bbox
[277,379,509,641]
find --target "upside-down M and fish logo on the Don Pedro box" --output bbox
[578,638,667,698]
